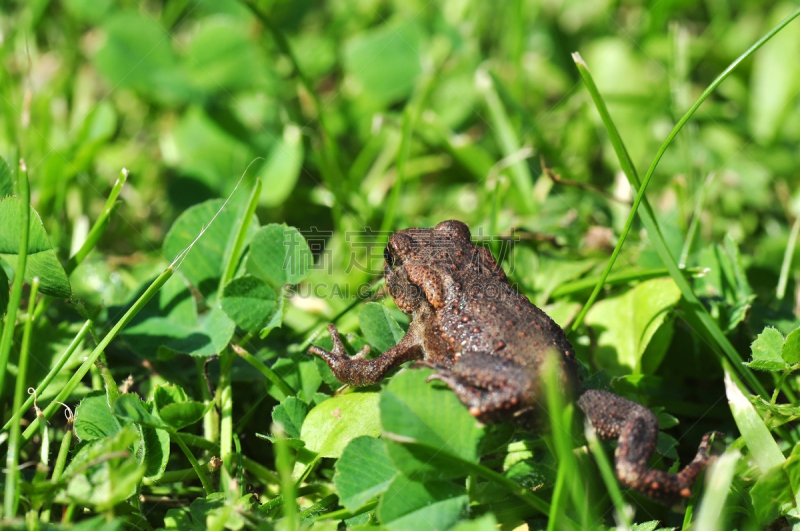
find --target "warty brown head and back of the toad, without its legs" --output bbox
[395,225,578,402]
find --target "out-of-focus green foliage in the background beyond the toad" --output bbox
[0,0,800,254]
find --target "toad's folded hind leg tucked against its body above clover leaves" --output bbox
[426,355,536,422]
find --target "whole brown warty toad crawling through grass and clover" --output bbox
[309,221,712,503]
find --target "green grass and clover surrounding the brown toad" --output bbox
[0,0,800,530]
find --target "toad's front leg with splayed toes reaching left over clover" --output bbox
[308,323,423,386]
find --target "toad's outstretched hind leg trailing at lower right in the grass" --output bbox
[578,390,714,503]
